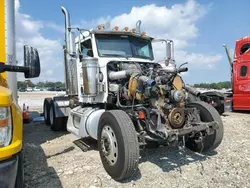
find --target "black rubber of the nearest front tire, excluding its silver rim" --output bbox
[98,110,139,181]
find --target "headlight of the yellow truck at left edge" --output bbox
[0,107,12,147]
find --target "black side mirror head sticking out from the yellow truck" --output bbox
[24,45,41,78]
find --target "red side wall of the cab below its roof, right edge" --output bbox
[233,42,250,110]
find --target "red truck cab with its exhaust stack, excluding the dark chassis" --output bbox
[223,36,250,111]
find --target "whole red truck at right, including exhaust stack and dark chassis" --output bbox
[190,36,250,114]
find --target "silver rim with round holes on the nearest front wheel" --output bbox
[101,125,118,166]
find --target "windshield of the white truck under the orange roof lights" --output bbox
[96,35,154,60]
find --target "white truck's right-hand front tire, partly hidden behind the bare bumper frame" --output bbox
[186,101,224,152]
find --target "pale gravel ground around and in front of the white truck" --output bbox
[24,113,250,188]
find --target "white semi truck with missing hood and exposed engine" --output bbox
[44,7,223,181]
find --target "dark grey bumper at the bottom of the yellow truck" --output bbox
[0,155,19,188]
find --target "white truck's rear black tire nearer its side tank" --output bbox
[49,100,68,131]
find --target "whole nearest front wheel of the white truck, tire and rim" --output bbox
[98,110,139,181]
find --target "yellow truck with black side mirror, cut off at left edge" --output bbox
[0,0,40,188]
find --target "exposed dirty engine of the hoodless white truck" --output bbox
[105,62,193,140]
